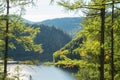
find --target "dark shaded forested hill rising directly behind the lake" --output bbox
[9,24,71,61]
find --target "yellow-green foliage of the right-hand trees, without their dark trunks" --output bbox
[53,0,120,80]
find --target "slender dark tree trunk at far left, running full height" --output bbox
[3,0,9,80]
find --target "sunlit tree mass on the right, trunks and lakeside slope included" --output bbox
[53,0,120,80]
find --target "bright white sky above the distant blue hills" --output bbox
[23,0,80,22]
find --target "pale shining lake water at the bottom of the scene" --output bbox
[8,65,76,80]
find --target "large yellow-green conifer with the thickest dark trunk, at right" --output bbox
[52,0,120,80]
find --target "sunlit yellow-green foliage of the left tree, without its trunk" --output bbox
[0,15,43,53]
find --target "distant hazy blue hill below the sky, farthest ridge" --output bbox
[37,17,82,36]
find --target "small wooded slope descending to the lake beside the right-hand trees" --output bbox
[53,37,83,62]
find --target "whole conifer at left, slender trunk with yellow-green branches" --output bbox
[0,0,42,80]
